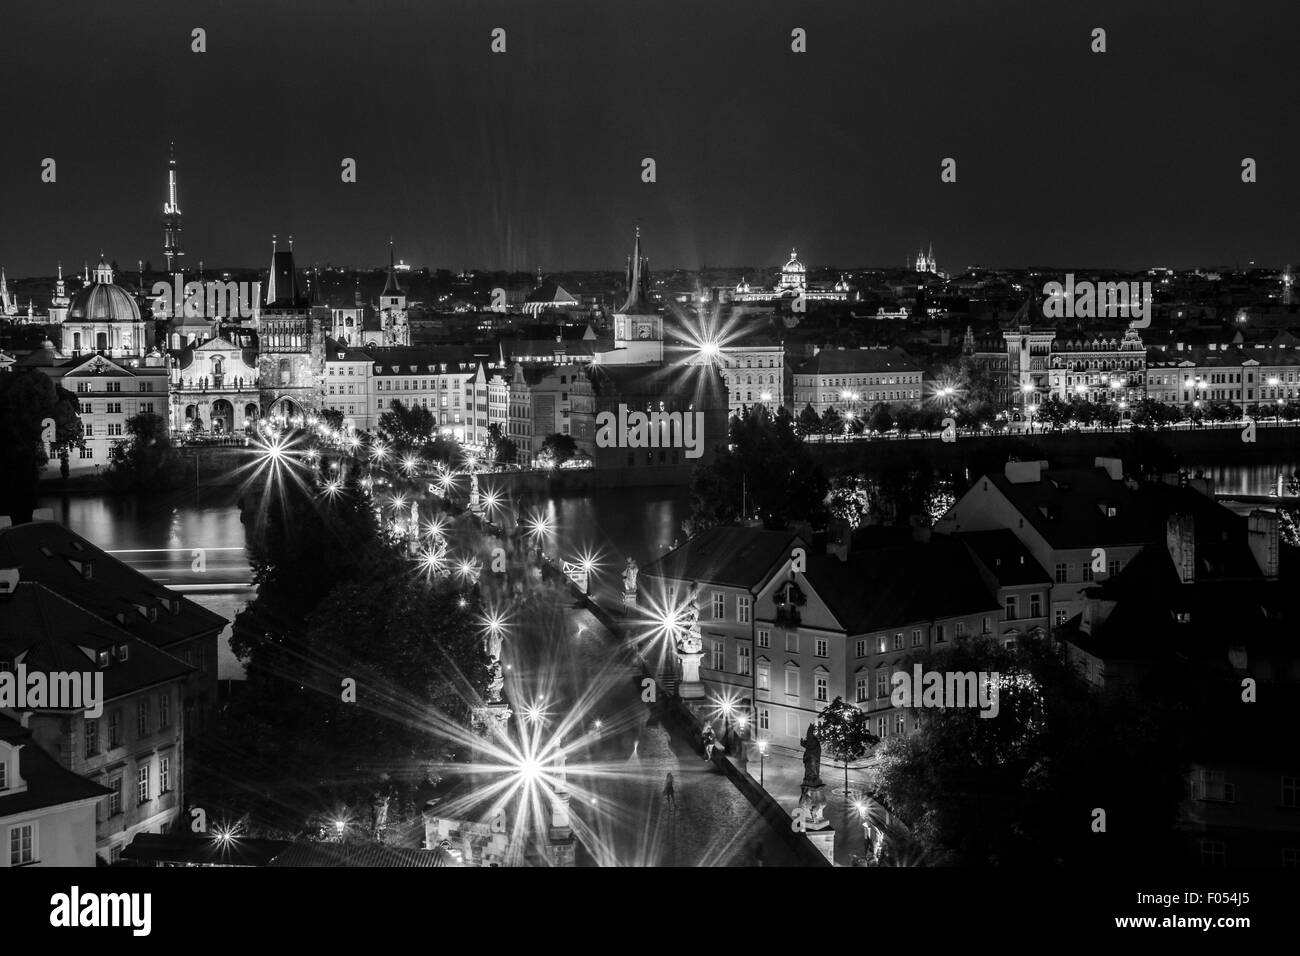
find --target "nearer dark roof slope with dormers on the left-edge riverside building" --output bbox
[0,580,194,700]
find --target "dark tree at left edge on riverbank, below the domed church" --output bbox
[0,368,85,524]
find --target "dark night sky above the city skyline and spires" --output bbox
[0,0,1300,276]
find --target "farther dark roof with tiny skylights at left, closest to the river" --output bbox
[0,522,226,649]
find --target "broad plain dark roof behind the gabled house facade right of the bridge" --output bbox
[803,536,998,635]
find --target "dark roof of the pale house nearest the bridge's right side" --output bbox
[642,527,800,591]
